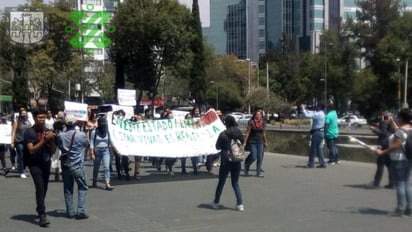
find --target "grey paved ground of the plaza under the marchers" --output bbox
[0,153,412,232]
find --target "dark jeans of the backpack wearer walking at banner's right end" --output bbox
[214,159,243,205]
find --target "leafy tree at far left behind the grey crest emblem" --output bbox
[0,0,82,112]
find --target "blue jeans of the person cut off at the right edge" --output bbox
[390,160,412,210]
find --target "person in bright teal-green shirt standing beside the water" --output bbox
[325,104,339,165]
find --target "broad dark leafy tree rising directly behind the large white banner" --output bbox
[111,0,193,109]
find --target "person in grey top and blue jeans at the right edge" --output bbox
[375,109,412,217]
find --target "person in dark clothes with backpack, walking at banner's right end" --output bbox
[210,116,244,211]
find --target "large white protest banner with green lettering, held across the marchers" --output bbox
[108,110,226,157]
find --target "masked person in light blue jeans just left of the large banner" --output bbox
[90,117,113,191]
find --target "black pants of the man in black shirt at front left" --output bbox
[29,162,50,215]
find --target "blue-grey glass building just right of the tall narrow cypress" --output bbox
[179,0,265,62]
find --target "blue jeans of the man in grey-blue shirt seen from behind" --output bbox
[62,166,89,216]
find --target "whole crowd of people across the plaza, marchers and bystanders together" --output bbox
[0,104,412,227]
